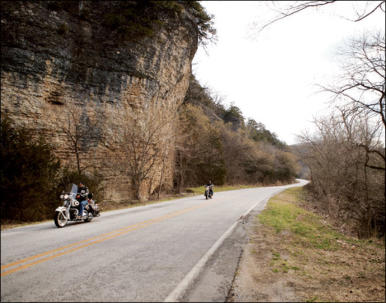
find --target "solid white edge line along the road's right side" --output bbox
[164,196,276,302]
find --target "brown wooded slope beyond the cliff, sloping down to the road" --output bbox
[175,76,299,189]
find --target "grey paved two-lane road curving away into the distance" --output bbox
[1,181,305,302]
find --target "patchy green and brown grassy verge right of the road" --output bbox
[231,188,385,302]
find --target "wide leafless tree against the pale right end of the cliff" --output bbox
[109,102,175,201]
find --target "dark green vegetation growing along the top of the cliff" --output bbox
[46,0,216,44]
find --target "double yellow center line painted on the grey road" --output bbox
[1,203,207,276]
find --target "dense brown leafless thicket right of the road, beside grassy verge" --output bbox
[301,110,385,236]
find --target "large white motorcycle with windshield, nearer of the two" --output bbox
[54,184,100,228]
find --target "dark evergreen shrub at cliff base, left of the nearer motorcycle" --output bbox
[0,117,60,221]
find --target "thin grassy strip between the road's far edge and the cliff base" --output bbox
[1,185,272,230]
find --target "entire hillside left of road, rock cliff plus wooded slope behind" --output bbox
[1,0,298,220]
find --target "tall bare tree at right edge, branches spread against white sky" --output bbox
[321,33,386,170]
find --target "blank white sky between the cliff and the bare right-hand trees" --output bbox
[193,1,385,144]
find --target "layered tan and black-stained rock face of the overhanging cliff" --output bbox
[1,1,198,200]
